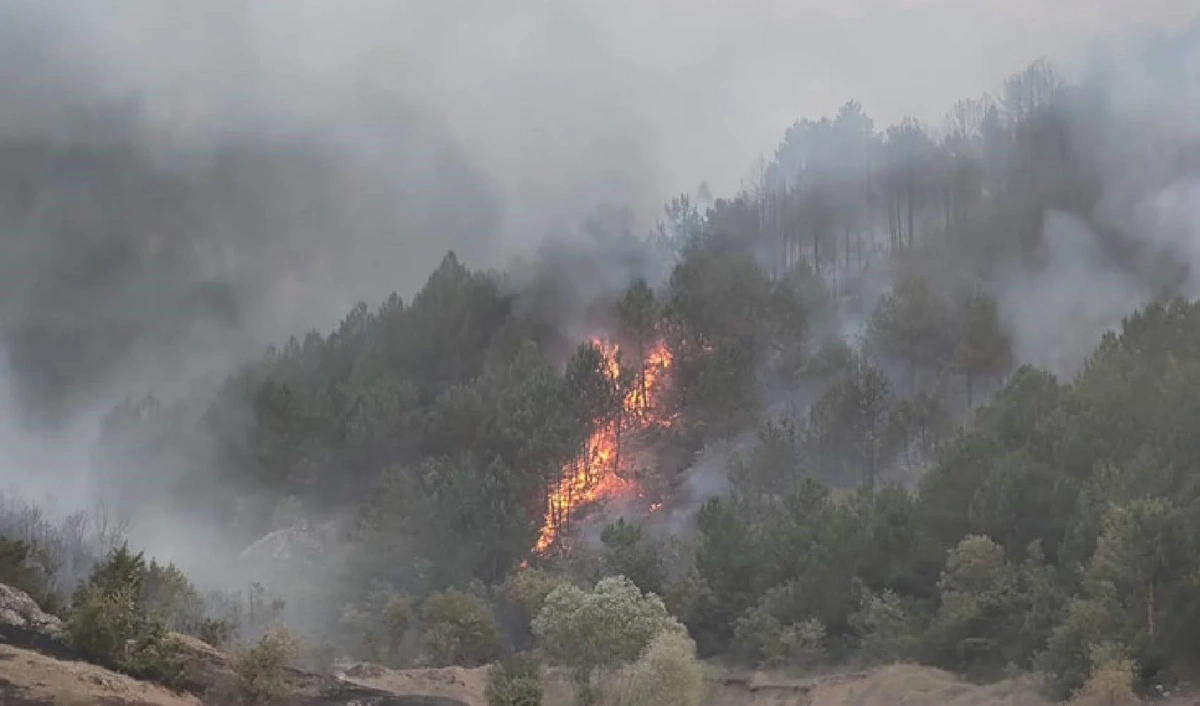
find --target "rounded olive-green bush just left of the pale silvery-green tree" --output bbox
[421,588,502,666]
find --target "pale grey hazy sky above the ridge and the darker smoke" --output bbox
[25,0,1200,243]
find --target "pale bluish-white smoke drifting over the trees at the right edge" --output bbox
[1000,22,1200,376]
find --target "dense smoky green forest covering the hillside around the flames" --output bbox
[2,48,1200,696]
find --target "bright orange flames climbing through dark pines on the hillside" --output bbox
[534,339,673,554]
